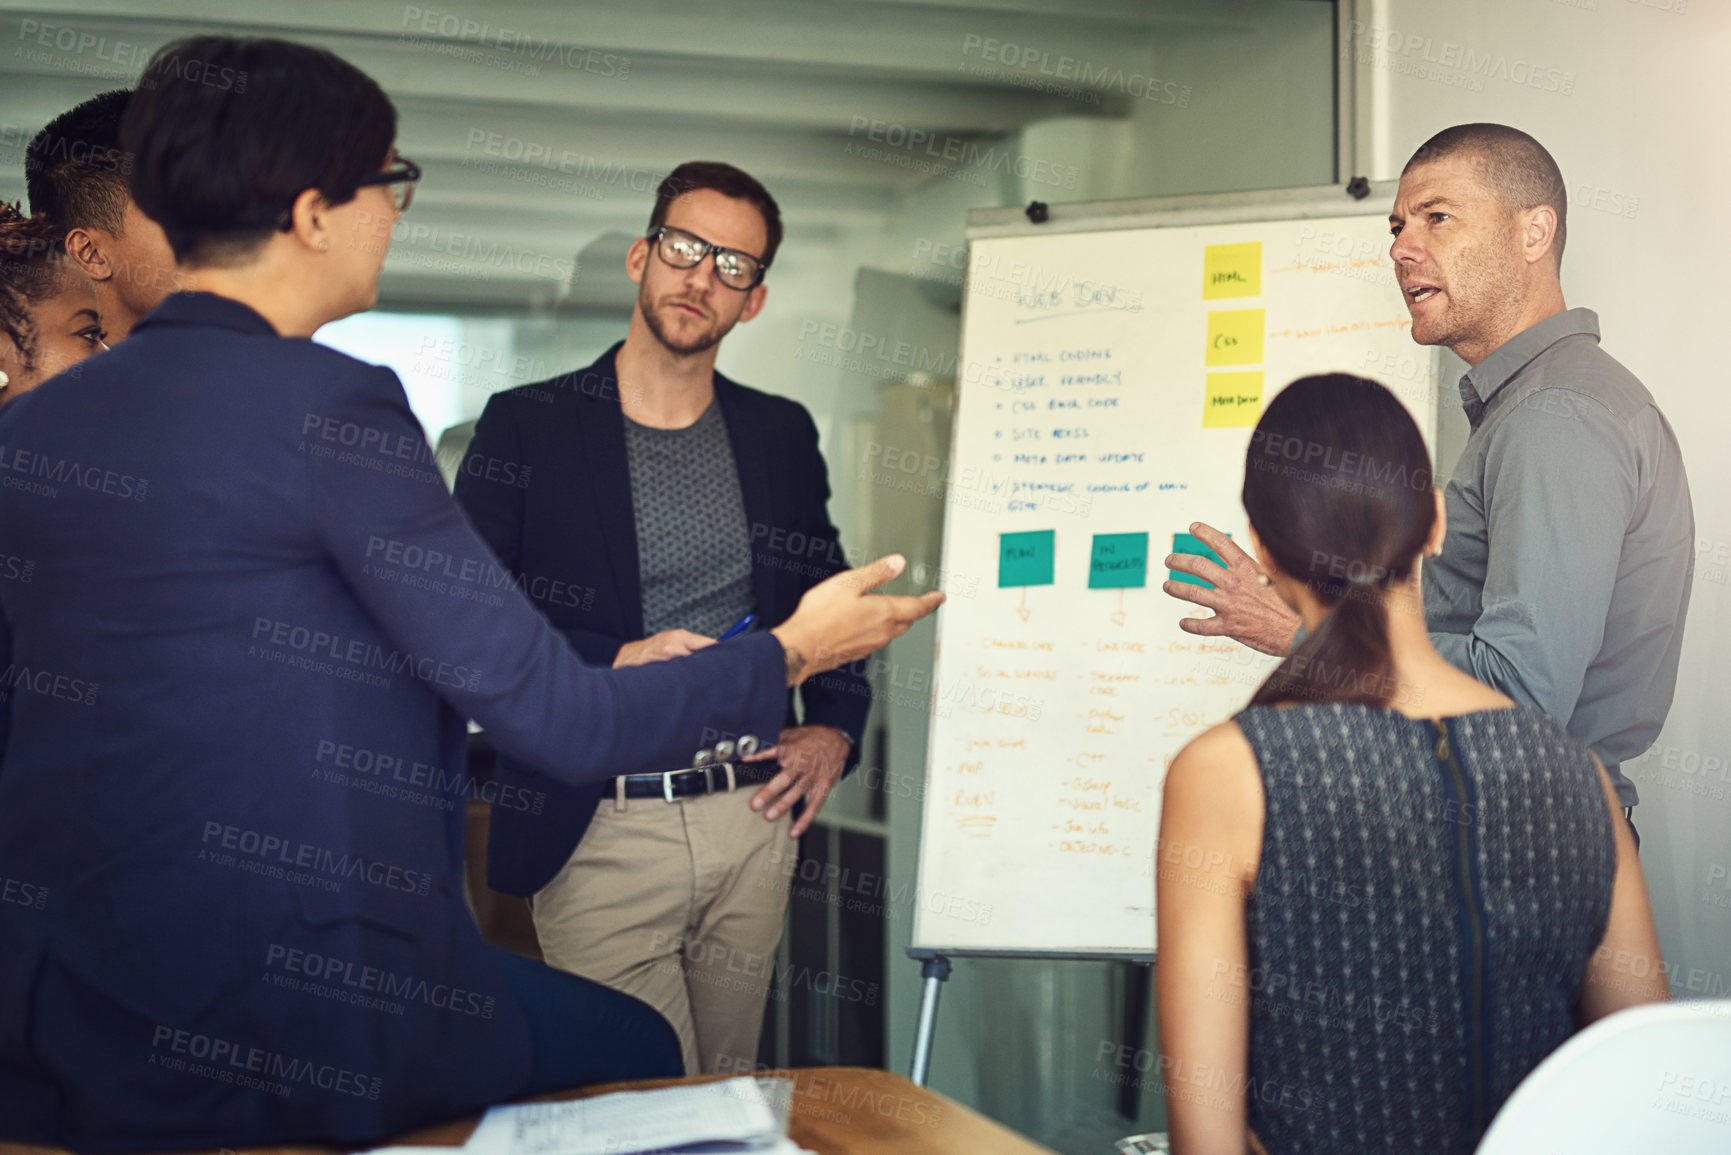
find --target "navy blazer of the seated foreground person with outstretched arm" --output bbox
[0,293,786,1150]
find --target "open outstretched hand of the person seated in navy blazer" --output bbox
[770,554,943,686]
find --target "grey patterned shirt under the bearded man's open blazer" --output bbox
[625,400,755,637]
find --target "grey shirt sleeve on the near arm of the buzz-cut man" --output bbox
[1432,388,1639,722]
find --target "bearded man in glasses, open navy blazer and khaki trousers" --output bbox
[455,161,871,1074]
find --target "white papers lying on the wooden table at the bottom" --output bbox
[462,1079,813,1155]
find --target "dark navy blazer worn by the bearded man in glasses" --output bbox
[457,345,871,895]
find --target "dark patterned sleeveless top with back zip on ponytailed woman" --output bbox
[1236,703,1617,1155]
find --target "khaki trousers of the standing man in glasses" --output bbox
[530,784,796,1075]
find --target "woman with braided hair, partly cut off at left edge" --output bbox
[0,201,107,403]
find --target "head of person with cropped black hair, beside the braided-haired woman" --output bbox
[24,88,177,345]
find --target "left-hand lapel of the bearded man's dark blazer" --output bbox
[571,346,644,637]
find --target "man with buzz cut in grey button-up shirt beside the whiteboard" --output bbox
[1165,125,1695,845]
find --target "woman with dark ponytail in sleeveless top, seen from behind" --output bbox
[1156,374,1667,1155]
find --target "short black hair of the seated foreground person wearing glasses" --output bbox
[119,36,396,267]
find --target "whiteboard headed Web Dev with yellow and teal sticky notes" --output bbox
[912,187,1437,958]
